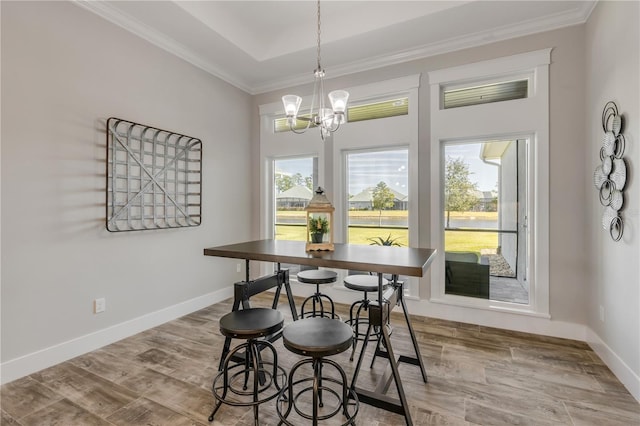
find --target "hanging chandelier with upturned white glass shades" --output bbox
[282,0,349,140]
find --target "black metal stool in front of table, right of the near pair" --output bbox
[276,318,360,426]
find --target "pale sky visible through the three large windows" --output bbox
[276,143,498,195]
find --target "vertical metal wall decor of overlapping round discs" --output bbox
[593,102,627,241]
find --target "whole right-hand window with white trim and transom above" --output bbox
[429,49,551,317]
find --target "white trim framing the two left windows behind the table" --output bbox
[259,74,420,299]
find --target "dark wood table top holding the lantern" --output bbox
[204,240,436,277]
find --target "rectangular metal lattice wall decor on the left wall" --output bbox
[107,117,202,232]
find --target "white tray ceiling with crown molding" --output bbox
[75,0,595,94]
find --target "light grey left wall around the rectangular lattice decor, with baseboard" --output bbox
[0,2,252,382]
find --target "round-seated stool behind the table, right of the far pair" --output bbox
[344,274,390,365]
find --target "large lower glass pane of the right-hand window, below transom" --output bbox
[442,138,530,304]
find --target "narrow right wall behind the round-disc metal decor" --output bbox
[583,1,640,400]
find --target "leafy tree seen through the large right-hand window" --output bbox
[444,157,478,228]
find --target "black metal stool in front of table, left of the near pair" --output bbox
[209,308,286,425]
